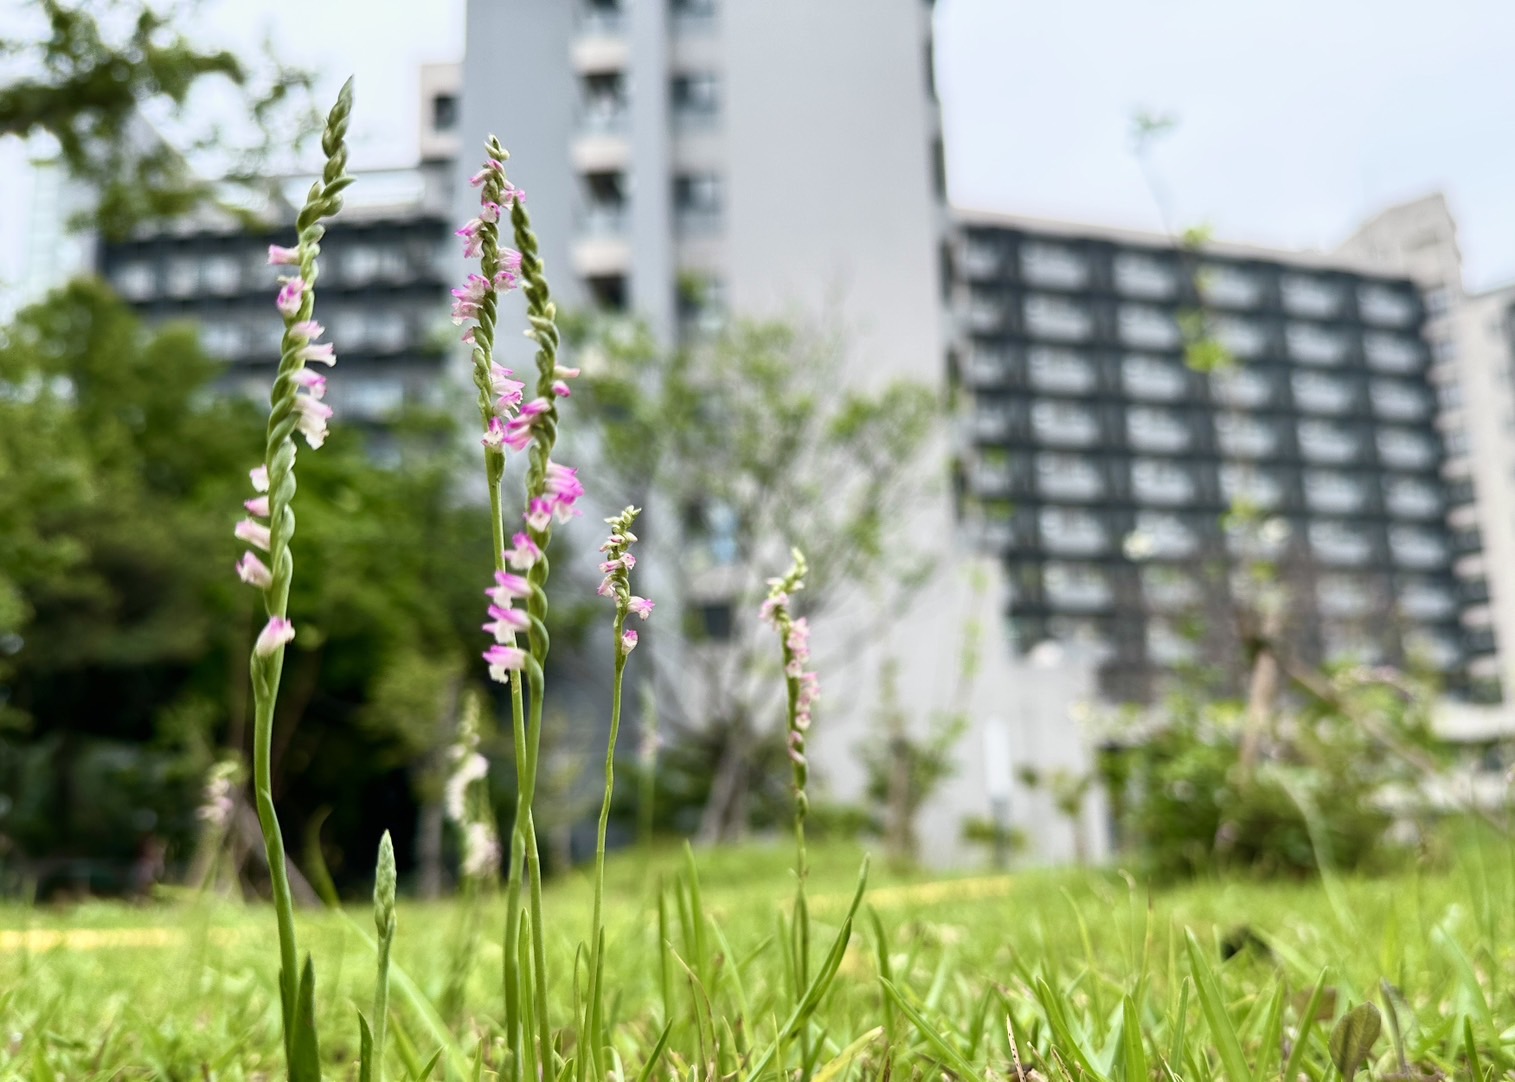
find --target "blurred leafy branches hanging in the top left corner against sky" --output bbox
[0,0,314,236]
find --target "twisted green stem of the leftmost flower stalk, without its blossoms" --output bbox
[251,79,353,1053]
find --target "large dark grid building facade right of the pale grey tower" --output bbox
[950,215,1498,702]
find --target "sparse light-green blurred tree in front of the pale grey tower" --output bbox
[568,312,939,843]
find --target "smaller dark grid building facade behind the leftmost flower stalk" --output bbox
[97,168,456,432]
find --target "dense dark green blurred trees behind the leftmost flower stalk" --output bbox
[0,282,489,868]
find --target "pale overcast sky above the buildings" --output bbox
[0,0,1515,288]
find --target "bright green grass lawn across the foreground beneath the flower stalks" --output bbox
[0,832,1515,1082]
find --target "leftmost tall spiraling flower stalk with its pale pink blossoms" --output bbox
[236,79,353,1077]
